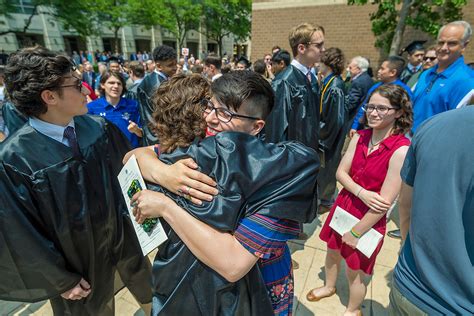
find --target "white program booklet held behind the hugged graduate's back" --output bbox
[118,155,168,256]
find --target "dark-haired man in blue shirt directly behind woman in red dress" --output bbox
[349,56,413,137]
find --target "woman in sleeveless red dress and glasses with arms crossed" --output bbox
[306,84,413,315]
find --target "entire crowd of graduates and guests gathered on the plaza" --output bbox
[0,21,474,315]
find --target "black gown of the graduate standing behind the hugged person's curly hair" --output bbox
[136,72,163,146]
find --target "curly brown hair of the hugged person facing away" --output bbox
[152,74,210,153]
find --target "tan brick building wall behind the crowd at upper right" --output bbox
[251,0,474,69]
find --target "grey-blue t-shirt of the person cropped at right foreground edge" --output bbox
[393,107,474,315]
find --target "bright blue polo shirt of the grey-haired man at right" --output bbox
[412,56,474,132]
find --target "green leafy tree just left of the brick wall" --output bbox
[203,0,252,55]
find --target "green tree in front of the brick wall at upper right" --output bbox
[348,0,467,55]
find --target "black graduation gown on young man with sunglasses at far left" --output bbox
[0,116,151,315]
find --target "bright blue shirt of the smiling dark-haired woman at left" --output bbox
[87,97,141,148]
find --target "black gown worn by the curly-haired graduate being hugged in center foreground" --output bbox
[148,132,319,316]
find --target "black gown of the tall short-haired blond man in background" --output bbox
[265,65,319,150]
